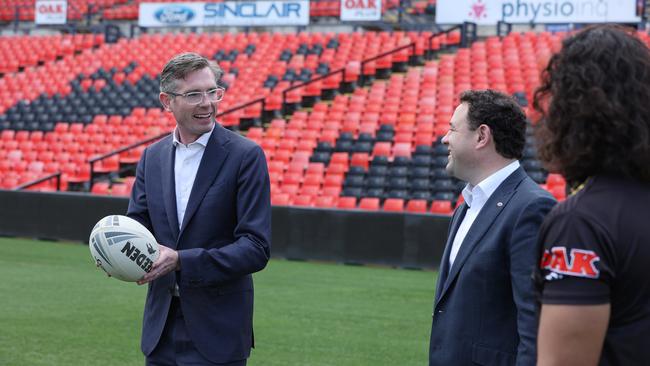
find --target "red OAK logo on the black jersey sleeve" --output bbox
[541,247,600,278]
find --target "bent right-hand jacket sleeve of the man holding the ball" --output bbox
[179,146,271,287]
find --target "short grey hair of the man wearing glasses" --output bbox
[160,52,223,93]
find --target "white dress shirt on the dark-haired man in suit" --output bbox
[449,160,519,268]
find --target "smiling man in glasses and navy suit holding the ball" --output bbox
[128,53,271,366]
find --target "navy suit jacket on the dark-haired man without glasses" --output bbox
[429,168,555,366]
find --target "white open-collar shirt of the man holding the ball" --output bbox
[173,126,214,229]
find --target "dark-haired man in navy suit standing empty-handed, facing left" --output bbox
[429,90,555,366]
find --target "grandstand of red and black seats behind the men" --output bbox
[0,0,588,215]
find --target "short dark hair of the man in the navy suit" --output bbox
[460,90,526,159]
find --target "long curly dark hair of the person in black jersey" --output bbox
[533,25,650,186]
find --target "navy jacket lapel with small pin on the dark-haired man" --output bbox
[438,168,526,300]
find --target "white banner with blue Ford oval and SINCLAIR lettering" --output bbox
[138,0,309,27]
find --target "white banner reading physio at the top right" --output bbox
[436,0,641,25]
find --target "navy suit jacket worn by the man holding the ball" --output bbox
[127,124,271,363]
